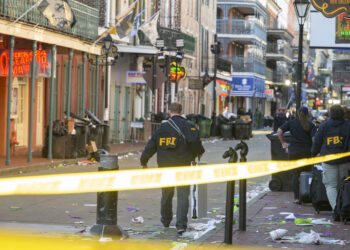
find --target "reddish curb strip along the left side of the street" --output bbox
[0,150,140,177]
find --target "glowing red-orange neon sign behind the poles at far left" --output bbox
[0,50,51,77]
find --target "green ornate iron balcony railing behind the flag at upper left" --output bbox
[0,0,99,40]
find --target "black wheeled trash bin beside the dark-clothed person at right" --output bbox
[266,132,293,192]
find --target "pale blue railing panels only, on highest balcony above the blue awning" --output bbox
[216,18,266,41]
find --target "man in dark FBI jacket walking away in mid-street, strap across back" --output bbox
[140,102,205,235]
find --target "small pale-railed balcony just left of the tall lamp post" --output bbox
[266,43,293,62]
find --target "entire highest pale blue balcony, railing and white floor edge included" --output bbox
[216,18,266,45]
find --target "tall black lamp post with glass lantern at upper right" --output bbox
[293,0,310,110]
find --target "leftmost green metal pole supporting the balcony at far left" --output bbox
[5,36,15,166]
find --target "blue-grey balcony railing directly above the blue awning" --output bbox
[221,56,266,75]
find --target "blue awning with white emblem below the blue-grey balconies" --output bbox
[231,76,265,98]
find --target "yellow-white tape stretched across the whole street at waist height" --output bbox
[0,152,350,195]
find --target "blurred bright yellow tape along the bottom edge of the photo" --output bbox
[0,232,270,250]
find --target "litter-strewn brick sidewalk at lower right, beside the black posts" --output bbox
[204,192,350,249]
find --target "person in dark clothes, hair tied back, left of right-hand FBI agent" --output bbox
[277,107,316,203]
